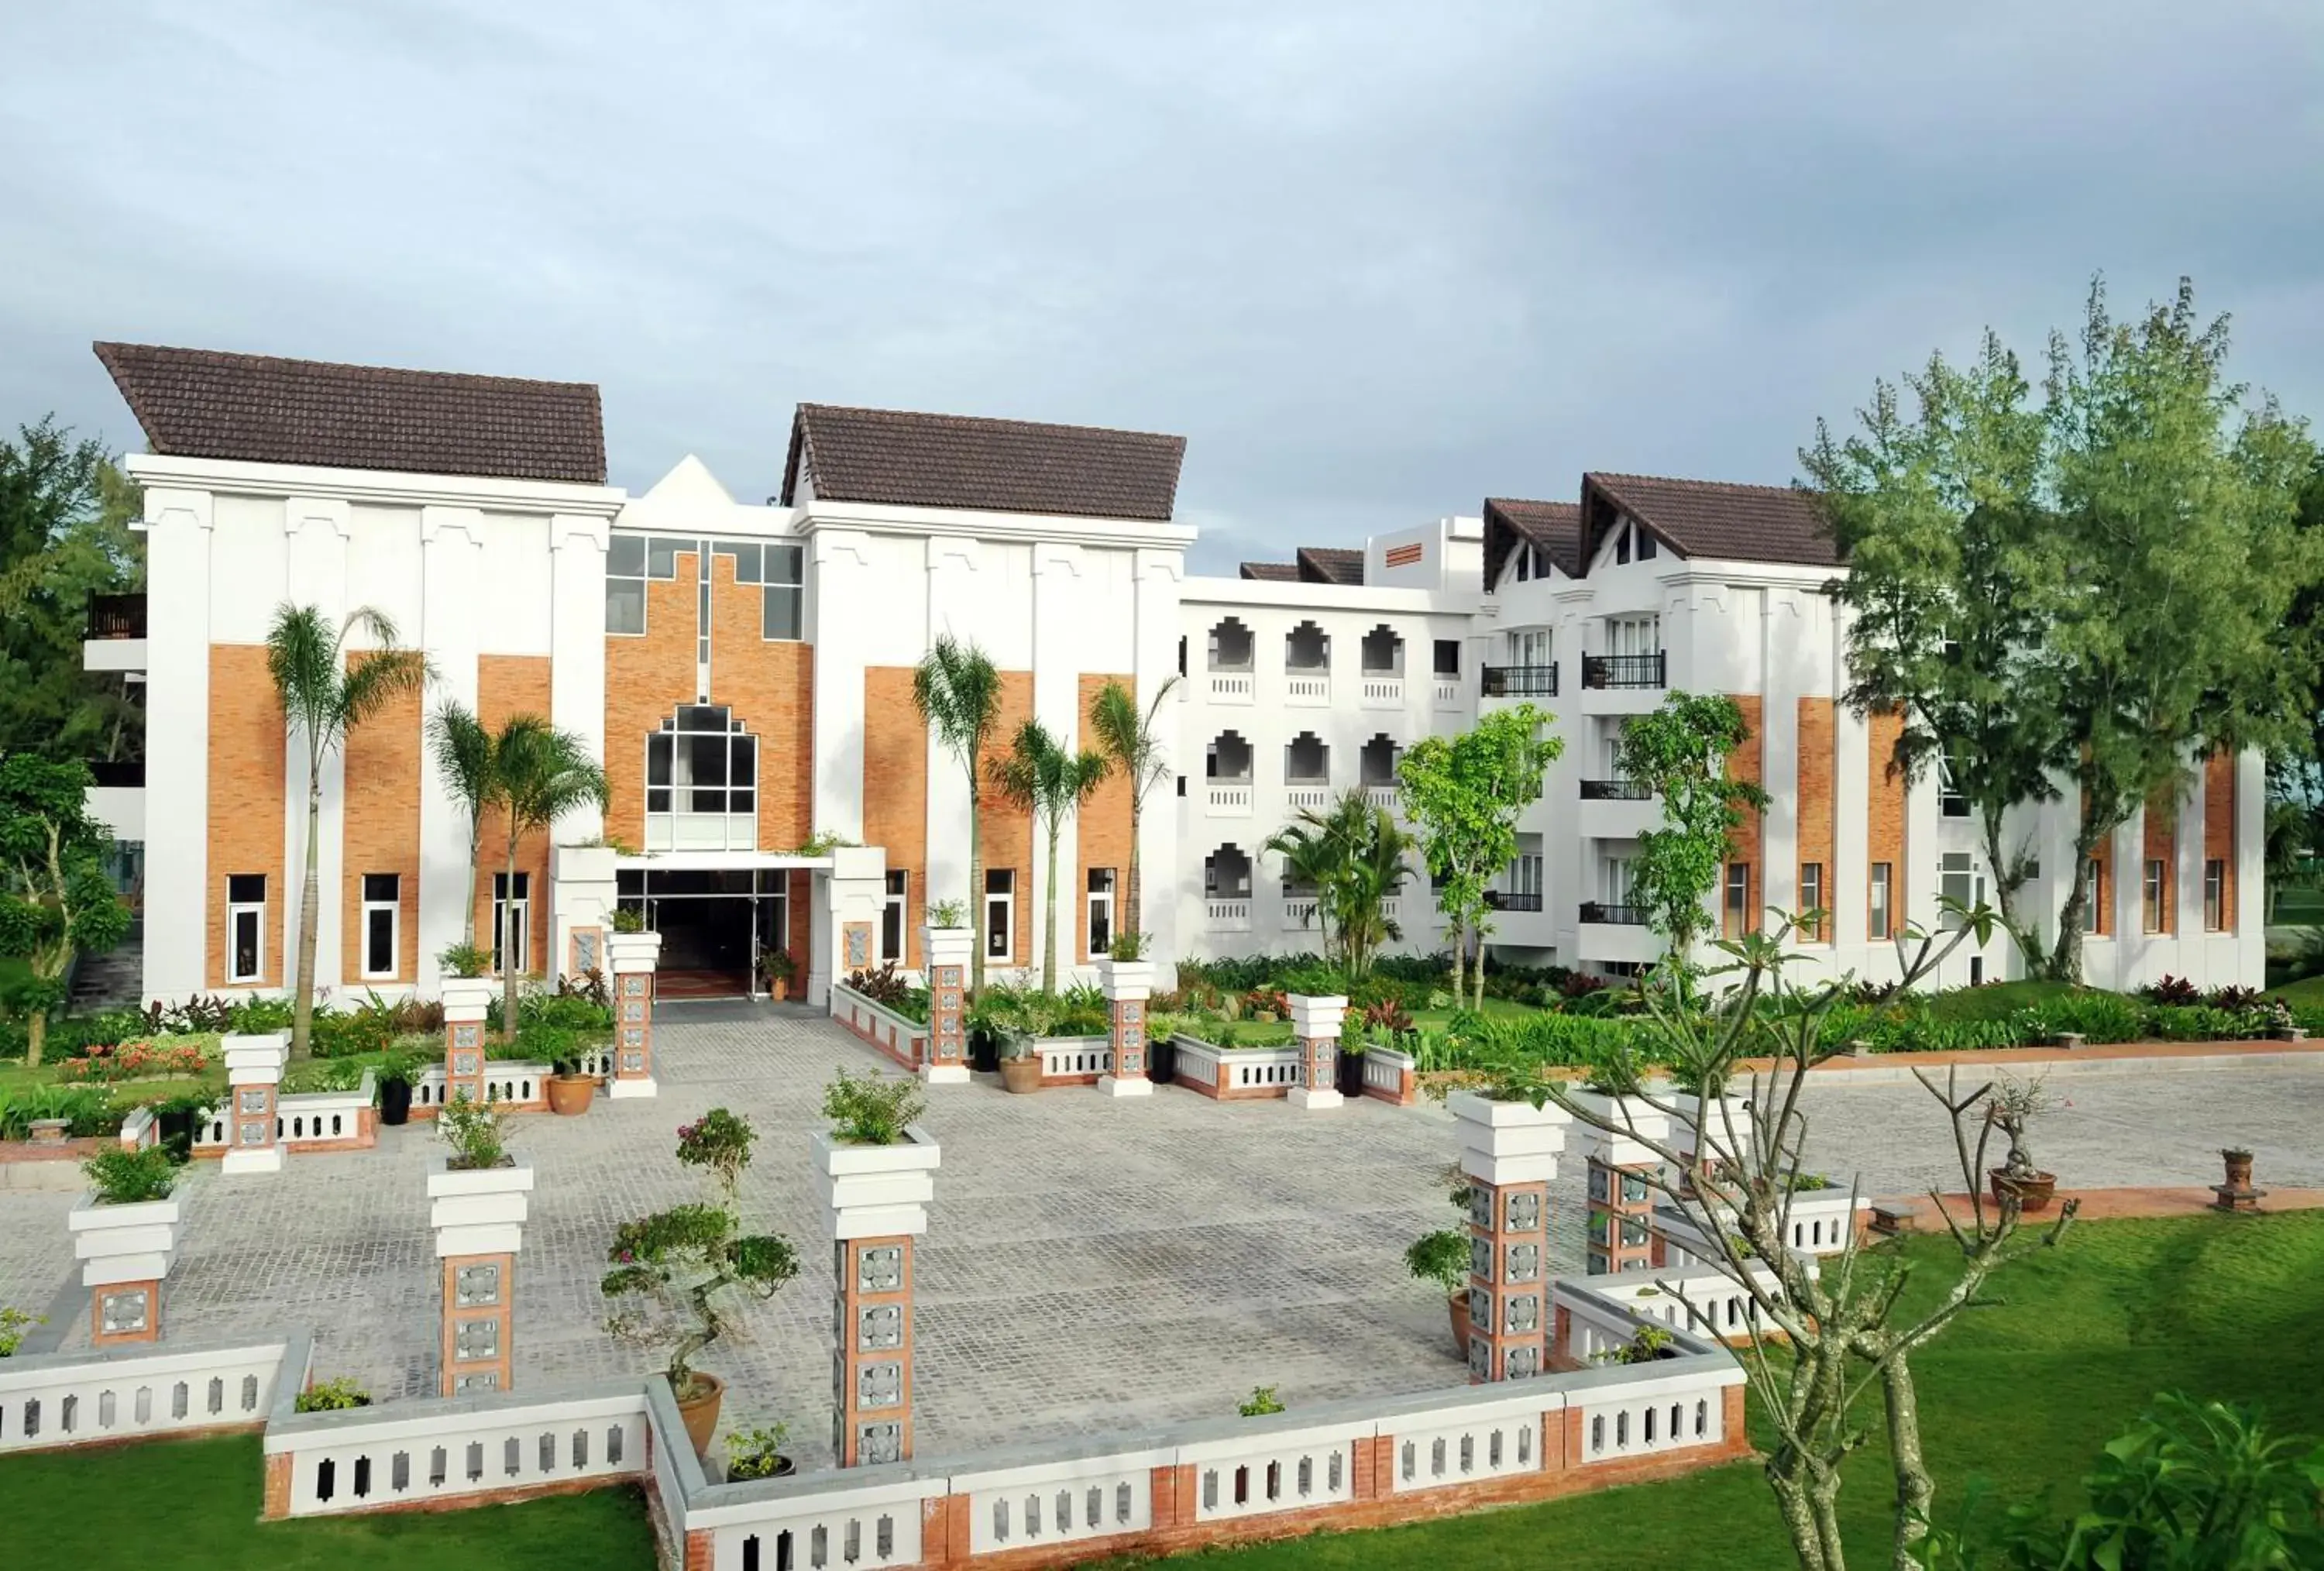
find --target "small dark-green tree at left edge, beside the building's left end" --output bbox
[0,753,130,1064]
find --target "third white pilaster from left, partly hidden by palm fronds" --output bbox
[418,507,486,995]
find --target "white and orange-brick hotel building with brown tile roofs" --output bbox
[88,344,2264,999]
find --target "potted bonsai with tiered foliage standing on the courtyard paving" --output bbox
[597,1106,799,1401]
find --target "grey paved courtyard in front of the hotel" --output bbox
[0,1004,2324,1466]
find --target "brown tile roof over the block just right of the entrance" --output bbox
[783,404,1185,518]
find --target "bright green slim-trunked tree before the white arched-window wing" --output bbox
[1397,704,1564,1009]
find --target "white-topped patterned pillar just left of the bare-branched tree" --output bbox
[1446,1090,1569,1385]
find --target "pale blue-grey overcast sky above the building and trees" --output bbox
[0,0,2324,569]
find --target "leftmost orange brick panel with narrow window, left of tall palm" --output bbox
[202,644,290,988]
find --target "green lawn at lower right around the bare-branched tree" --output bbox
[1088,1211,2324,1571]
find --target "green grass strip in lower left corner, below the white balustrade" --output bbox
[0,1434,653,1571]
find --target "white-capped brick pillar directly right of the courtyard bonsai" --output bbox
[816,1125,941,1466]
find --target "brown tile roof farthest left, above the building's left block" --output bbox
[95,344,604,486]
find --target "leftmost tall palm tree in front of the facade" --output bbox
[267,602,430,1057]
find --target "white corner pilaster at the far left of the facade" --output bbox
[144,488,225,999]
